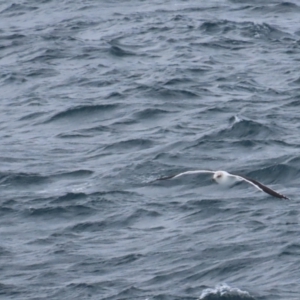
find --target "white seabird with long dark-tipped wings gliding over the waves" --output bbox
[154,170,289,199]
